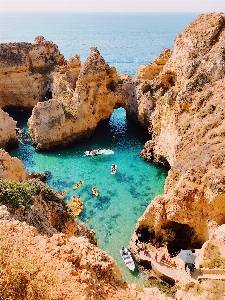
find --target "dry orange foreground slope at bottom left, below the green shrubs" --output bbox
[0,218,169,300]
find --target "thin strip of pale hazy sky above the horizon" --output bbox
[0,0,225,13]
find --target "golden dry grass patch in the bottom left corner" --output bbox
[0,233,56,300]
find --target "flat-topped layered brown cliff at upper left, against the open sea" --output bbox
[0,36,66,109]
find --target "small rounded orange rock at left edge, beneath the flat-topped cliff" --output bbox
[0,109,17,149]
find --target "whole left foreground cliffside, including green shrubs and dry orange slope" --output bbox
[0,150,169,300]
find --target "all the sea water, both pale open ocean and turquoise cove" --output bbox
[0,12,198,285]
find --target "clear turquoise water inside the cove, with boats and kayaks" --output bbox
[10,108,167,282]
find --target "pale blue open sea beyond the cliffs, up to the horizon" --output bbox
[0,12,199,76]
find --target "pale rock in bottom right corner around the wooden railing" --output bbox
[176,225,225,300]
